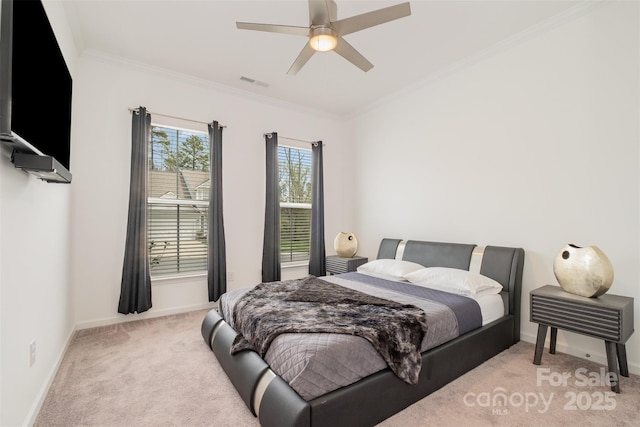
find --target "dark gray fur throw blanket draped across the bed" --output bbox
[231,276,427,384]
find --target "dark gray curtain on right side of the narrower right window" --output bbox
[309,141,327,276]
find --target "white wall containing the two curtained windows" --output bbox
[71,55,353,327]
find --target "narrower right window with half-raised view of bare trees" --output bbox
[278,146,311,263]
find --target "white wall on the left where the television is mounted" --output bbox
[0,2,76,426]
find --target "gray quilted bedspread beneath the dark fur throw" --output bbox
[219,273,482,400]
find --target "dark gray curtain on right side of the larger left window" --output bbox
[208,121,227,301]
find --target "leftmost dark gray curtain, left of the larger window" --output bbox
[118,107,151,314]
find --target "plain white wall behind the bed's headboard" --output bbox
[353,2,640,373]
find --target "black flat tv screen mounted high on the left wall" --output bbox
[0,0,72,175]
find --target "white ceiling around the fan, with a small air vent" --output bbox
[64,0,585,117]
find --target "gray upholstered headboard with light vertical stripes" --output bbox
[378,238,524,339]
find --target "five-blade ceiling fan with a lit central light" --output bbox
[236,0,411,75]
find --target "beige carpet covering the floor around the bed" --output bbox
[35,310,640,427]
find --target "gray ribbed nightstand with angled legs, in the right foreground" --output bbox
[530,285,633,393]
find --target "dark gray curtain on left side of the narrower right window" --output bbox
[262,132,280,282]
